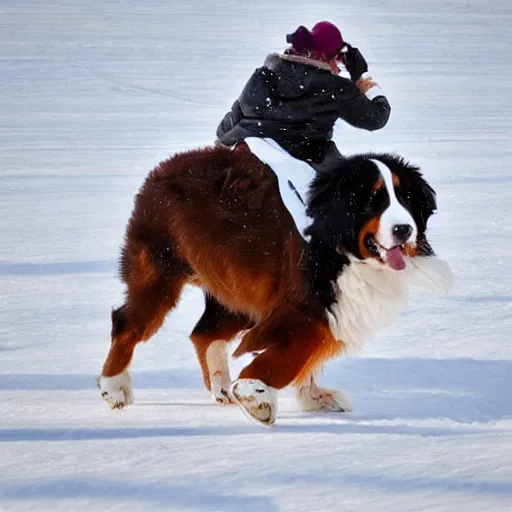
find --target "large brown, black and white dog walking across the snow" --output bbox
[99,140,451,424]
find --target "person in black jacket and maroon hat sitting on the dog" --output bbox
[217,21,391,170]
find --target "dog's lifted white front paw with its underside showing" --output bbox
[231,379,277,426]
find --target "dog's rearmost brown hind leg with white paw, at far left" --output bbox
[98,246,188,408]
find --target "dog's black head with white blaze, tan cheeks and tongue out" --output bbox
[306,154,436,271]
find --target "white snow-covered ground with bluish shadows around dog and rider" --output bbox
[0,0,512,512]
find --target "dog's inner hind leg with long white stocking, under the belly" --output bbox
[190,294,250,404]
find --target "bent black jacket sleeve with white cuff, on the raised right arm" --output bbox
[339,81,391,131]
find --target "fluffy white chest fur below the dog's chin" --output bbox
[328,256,452,348]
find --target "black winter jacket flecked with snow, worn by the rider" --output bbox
[217,54,391,162]
